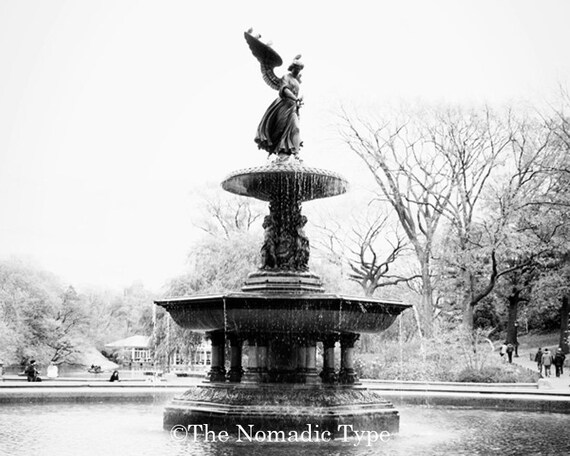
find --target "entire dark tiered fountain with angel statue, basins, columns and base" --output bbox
[156,31,409,435]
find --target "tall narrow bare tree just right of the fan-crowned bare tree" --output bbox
[427,107,512,328]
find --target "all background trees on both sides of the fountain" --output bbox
[4,93,570,363]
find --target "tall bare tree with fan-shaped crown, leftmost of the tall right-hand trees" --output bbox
[340,105,454,335]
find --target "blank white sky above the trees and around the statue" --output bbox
[0,0,570,288]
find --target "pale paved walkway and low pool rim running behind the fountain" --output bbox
[0,356,570,413]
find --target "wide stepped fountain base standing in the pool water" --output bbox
[164,383,400,437]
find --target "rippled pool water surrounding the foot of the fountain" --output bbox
[0,403,570,456]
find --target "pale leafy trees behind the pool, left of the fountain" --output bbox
[0,258,154,366]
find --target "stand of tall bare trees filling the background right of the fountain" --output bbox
[330,93,570,350]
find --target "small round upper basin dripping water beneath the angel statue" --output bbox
[222,158,348,202]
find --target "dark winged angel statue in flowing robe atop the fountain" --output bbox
[244,29,304,156]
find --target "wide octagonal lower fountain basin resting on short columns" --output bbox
[155,292,411,333]
